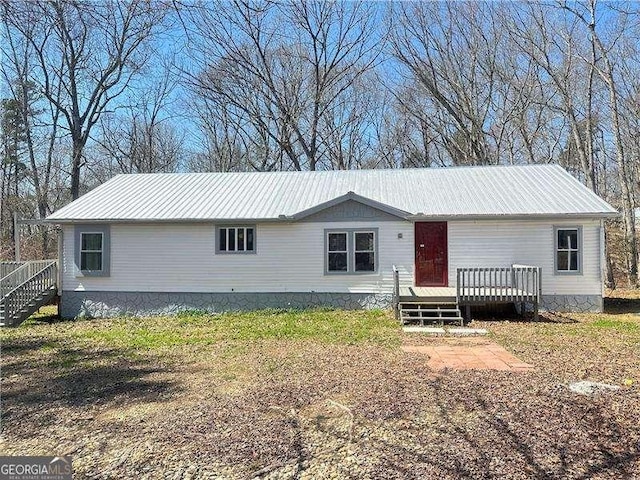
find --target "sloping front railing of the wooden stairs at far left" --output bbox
[0,260,58,325]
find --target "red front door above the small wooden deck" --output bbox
[416,222,448,287]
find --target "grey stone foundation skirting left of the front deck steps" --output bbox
[60,290,392,318]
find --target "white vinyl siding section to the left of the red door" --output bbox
[63,220,414,293]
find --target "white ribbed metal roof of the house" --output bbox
[48,165,617,223]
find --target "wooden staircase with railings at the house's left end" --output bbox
[0,260,58,327]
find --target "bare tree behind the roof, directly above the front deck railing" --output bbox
[391,2,500,164]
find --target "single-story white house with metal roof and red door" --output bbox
[48,165,618,317]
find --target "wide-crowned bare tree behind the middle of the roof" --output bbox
[184,1,380,170]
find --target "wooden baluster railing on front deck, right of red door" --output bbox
[456,265,541,305]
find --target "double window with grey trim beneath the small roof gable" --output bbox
[325,229,377,274]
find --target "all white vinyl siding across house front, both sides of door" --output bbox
[62,220,602,295]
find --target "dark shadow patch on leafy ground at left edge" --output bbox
[2,338,180,432]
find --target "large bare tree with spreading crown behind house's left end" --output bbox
[2,0,164,199]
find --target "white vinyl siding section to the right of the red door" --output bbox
[449,220,602,295]
